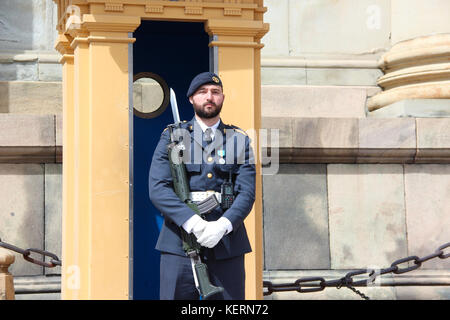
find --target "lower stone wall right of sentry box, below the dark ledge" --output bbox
[264,164,450,299]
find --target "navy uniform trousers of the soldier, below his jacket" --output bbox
[160,252,245,300]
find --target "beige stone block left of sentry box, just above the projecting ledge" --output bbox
[0,81,62,114]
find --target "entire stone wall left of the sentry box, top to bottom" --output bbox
[0,0,62,299]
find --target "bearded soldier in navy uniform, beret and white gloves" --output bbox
[149,72,255,300]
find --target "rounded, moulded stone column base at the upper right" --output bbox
[367,34,450,111]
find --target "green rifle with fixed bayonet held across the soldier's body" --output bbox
[167,88,223,300]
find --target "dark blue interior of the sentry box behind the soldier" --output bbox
[133,21,209,299]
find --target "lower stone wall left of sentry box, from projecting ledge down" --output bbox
[0,114,62,299]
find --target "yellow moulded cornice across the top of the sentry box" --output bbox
[54,0,269,49]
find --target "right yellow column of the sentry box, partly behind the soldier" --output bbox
[206,20,264,300]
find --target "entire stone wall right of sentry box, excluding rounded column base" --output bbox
[261,0,450,299]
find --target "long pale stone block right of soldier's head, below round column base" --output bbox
[261,85,380,118]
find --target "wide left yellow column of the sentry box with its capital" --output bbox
[62,14,140,299]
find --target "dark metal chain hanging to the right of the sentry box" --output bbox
[263,242,450,300]
